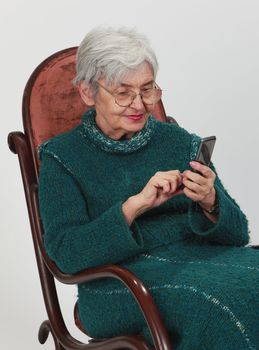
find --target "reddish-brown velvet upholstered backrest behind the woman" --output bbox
[23,47,169,174]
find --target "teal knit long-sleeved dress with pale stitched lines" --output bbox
[39,109,259,350]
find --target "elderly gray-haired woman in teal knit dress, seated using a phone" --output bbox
[39,28,259,350]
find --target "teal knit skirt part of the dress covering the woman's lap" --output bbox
[79,241,259,350]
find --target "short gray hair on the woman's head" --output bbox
[74,27,158,86]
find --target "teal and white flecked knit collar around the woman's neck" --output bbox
[82,109,157,153]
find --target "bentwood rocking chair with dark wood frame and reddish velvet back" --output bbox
[8,47,175,350]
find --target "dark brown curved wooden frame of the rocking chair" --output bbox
[8,47,173,350]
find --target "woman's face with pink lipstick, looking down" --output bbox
[94,62,154,140]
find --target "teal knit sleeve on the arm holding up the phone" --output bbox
[188,164,249,246]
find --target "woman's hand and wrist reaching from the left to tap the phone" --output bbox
[122,170,183,225]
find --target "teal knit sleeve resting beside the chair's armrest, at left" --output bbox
[39,154,143,273]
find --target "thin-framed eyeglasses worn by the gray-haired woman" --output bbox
[96,81,162,107]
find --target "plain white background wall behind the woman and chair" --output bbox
[0,0,259,350]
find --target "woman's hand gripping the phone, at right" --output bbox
[182,161,216,210]
